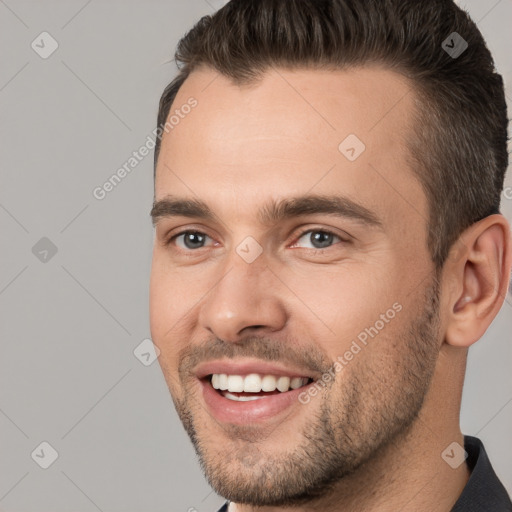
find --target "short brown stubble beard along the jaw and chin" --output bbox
[171,279,439,507]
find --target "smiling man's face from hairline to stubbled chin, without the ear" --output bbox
[150,68,441,506]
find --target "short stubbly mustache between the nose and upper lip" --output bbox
[178,336,333,378]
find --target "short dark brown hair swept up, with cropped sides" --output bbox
[155,0,508,269]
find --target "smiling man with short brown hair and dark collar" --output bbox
[150,0,512,512]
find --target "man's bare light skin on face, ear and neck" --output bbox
[150,67,512,512]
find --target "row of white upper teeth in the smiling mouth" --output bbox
[212,373,309,393]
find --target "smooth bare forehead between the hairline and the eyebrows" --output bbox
[155,68,427,230]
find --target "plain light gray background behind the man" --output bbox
[0,0,512,512]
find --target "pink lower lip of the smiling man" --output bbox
[200,380,313,425]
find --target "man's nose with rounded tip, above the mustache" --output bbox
[199,253,287,342]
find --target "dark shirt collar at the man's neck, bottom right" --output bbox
[218,436,512,512]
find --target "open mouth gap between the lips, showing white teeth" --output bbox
[205,373,313,402]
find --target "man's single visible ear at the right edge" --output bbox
[443,214,512,347]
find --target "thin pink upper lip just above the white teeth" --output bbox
[194,359,319,380]
